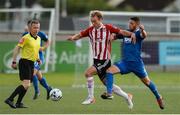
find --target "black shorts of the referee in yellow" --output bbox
[19,59,34,81]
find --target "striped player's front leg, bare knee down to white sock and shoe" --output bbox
[82,66,97,105]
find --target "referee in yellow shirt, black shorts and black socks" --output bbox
[5,20,41,109]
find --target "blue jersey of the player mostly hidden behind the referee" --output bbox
[22,31,48,63]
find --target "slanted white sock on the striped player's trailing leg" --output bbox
[113,84,128,99]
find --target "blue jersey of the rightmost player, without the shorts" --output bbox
[116,29,144,61]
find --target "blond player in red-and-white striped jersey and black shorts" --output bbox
[68,10,135,108]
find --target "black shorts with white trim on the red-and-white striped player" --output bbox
[93,59,111,80]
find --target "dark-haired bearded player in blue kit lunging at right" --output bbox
[101,17,164,109]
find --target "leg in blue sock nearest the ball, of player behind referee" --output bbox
[37,70,52,100]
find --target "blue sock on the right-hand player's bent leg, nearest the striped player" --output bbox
[106,73,113,94]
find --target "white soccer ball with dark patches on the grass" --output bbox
[49,88,62,101]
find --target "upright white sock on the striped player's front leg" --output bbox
[87,77,94,98]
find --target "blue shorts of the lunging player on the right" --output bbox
[114,60,148,78]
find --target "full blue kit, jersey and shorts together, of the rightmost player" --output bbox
[114,29,148,78]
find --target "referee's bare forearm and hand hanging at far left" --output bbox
[11,46,21,69]
